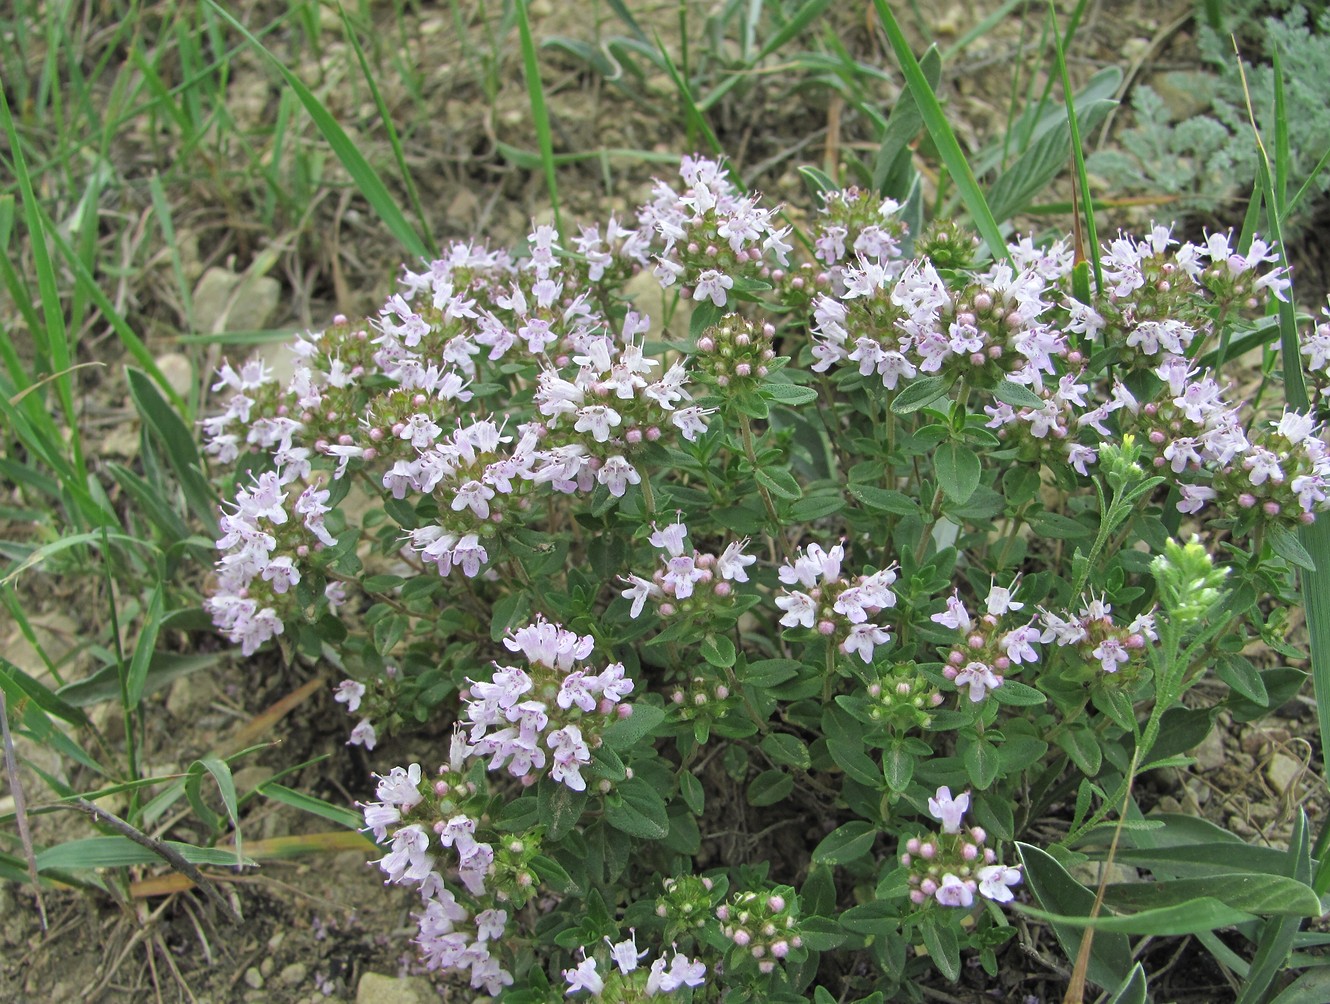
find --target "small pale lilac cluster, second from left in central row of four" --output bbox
[775,544,896,664]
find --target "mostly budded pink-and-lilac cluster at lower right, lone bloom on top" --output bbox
[900,786,1021,910]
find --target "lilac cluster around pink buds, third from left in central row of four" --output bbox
[930,584,1039,703]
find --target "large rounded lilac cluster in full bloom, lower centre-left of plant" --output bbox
[463,618,633,791]
